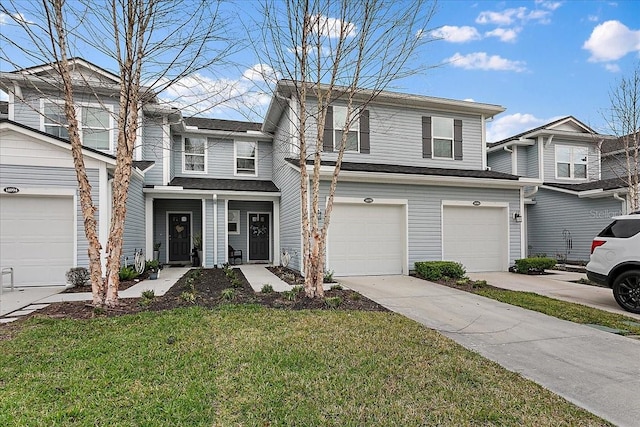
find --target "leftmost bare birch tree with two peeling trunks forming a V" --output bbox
[0,0,232,307]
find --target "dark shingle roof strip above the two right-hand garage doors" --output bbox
[287,159,519,180]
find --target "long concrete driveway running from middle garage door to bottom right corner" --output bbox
[337,276,640,426]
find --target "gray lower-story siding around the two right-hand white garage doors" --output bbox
[320,182,522,270]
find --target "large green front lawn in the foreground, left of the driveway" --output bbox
[0,306,607,426]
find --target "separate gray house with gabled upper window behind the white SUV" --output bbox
[487,116,627,261]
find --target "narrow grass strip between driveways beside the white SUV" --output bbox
[474,287,640,335]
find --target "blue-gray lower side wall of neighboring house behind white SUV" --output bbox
[527,188,622,262]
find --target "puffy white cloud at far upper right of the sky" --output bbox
[582,21,640,62]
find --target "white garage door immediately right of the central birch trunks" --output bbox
[327,203,406,276]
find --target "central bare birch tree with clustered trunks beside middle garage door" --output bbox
[259,0,435,297]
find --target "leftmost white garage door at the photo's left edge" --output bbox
[0,196,74,286]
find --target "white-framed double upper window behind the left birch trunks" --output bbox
[42,101,113,151]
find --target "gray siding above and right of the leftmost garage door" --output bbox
[0,165,99,267]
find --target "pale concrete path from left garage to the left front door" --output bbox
[0,267,190,323]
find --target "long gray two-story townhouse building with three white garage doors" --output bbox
[0,59,537,285]
